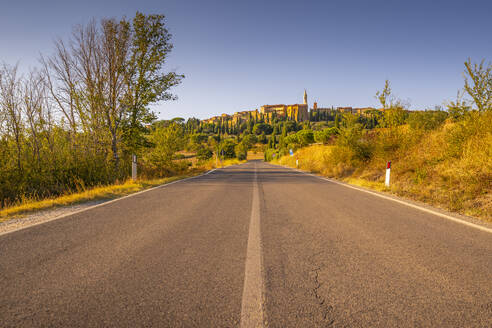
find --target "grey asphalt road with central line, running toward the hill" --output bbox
[0,161,492,327]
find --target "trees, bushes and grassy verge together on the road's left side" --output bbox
[0,12,245,220]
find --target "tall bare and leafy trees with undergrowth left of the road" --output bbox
[0,12,183,207]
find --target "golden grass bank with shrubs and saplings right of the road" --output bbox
[267,61,492,221]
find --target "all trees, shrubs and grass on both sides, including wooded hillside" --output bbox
[0,12,492,220]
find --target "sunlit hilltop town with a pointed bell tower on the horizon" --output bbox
[202,90,384,124]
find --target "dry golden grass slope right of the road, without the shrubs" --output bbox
[273,113,492,222]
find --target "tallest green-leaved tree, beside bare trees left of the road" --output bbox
[121,12,184,152]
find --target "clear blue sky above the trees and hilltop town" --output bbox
[0,0,492,118]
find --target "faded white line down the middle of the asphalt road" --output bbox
[240,163,267,328]
